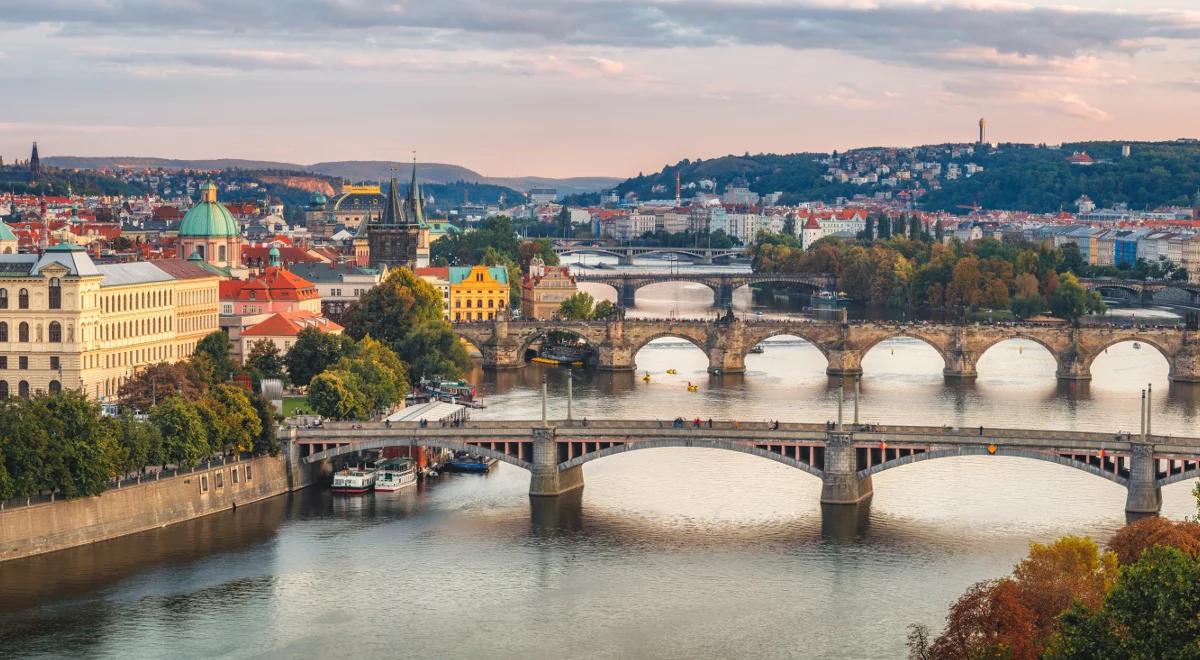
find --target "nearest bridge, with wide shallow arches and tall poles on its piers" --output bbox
[290,420,1200,514]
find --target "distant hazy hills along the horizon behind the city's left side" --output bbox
[42,156,620,194]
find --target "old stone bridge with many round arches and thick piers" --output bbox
[454,318,1200,383]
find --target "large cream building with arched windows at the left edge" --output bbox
[0,244,220,401]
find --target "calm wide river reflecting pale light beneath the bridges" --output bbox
[0,260,1200,659]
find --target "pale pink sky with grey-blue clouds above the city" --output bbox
[0,0,1200,176]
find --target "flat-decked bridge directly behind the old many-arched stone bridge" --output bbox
[575,272,838,308]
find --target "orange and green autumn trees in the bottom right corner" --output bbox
[908,486,1200,660]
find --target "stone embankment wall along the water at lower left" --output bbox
[0,451,320,562]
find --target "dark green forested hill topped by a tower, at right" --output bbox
[617,140,1200,212]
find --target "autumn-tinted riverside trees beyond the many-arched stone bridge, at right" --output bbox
[752,232,1106,319]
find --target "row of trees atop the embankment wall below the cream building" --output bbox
[0,332,278,500]
